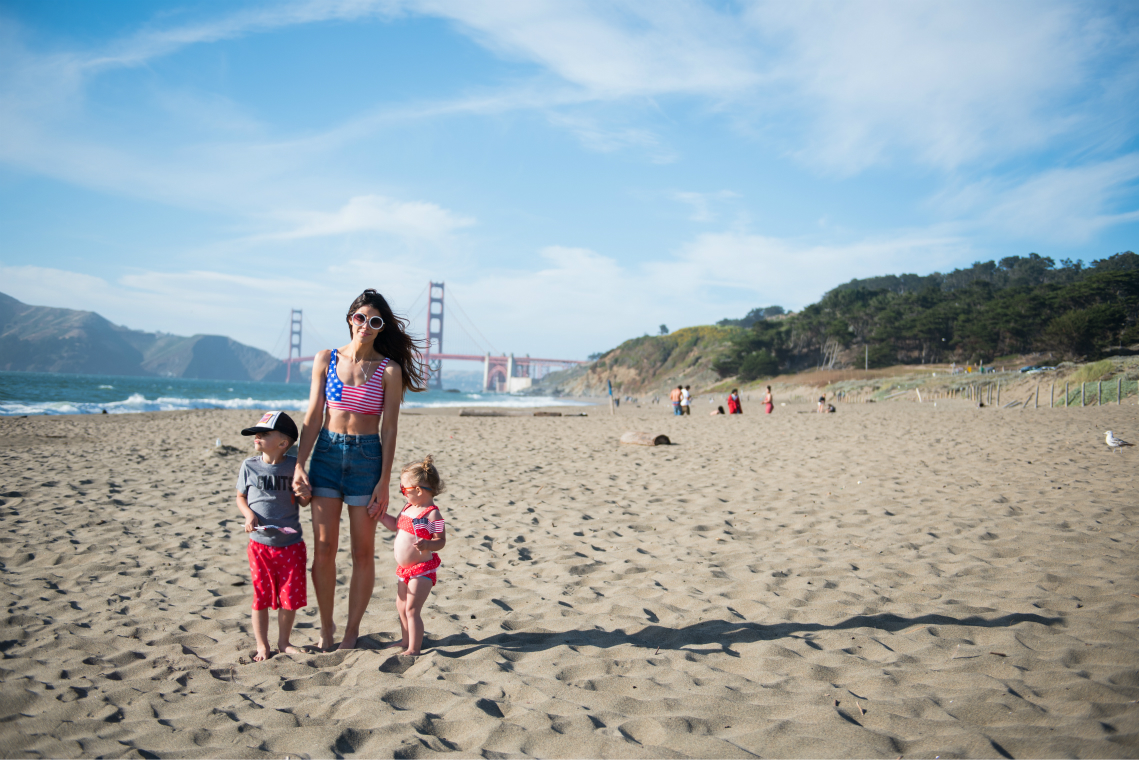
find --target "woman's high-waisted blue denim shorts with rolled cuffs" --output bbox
[309,427,383,507]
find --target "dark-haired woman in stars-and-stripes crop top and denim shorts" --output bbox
[293,288,426,652]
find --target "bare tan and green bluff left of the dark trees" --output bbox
[533,326,740,395]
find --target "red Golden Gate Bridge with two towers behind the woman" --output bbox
[275,283,585,393]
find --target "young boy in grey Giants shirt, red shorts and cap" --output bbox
[237,411,311,662]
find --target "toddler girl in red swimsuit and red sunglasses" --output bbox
[379,455,446,656]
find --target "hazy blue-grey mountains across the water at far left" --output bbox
[0,293,285,382]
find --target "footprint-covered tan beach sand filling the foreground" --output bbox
[0,399,1139,758]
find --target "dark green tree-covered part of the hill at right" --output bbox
[713,251,1139,382]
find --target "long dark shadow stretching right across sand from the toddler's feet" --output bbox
[431,611,1064,657]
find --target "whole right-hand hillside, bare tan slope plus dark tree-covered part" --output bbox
[535,251,1139,395]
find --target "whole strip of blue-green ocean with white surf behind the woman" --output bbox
[0,371,588,417]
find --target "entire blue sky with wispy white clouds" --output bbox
[0,0,1139,358]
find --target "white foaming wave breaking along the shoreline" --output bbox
[0,393,590,417]
